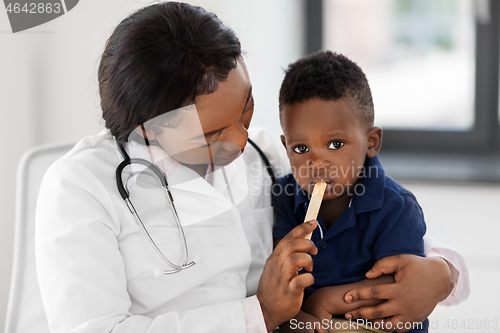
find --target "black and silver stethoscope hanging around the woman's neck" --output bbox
[116,138,276,277]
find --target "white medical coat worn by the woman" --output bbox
[36,130,286,333]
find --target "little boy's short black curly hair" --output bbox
[279,51,374,126]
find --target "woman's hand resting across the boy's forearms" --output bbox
[344,254,451,332]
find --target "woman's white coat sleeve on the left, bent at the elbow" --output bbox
[36,161,250,333]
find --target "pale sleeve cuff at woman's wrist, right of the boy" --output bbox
[424,235,470,306]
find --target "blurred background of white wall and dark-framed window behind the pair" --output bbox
[0,0,500,332]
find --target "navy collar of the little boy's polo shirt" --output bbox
[292,155,385,214]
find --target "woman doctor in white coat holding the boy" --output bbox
[36,2,468,333]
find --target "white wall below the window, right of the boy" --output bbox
[403,183,500,333]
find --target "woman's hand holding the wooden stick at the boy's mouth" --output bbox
[257,221,318,331]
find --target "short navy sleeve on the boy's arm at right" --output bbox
[373,193,426,261]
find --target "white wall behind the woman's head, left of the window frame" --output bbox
[0,0,303,330]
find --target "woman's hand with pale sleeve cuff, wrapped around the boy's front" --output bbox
[344,231,469,324]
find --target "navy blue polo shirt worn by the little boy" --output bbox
[273,156,428,332]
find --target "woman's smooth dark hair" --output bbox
[98,2,241,143]
